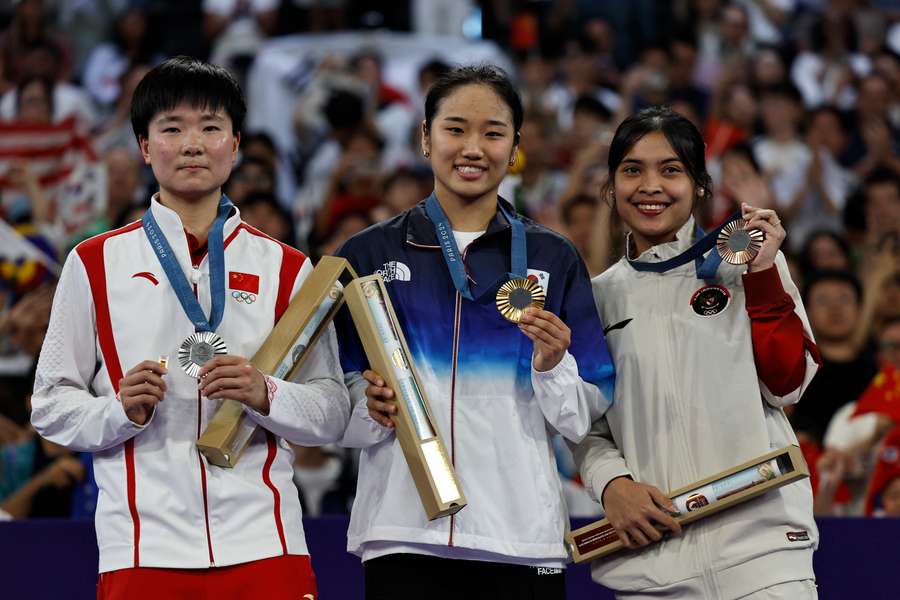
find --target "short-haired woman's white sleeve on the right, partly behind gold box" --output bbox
[244,260,350,446]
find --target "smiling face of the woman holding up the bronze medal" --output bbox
[614,131,695,254]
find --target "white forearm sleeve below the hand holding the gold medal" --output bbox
[531,350,612,443]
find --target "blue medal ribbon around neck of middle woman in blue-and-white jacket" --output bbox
[425,192,528,300]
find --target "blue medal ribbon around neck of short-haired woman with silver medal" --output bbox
[141,195,234,331]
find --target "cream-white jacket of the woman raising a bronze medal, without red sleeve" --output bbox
[575,219,818,599]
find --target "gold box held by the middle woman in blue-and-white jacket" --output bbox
[344,274,466,520]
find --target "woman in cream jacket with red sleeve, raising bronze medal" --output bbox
[575,108,819,600]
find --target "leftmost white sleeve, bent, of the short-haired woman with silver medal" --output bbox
[31,251,152,452]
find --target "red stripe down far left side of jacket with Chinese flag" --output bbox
[75,221,141,567]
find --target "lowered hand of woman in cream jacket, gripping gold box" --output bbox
[603,477,681,550]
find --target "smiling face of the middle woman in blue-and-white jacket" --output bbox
[422,84,515,205]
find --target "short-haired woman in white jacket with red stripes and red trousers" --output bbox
[31,58,350,600]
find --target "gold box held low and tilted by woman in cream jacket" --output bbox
[566,446,809,563]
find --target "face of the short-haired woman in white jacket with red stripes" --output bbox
[139,104,240,203]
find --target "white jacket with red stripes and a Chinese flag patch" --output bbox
[31,199,349,572]
